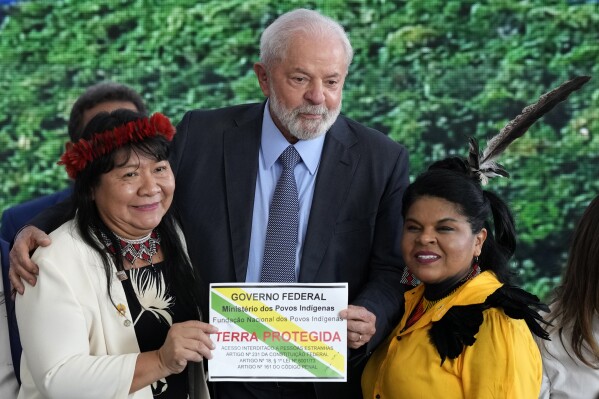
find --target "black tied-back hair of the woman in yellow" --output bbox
[402,157,516,284]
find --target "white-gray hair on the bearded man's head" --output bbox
[260,8,354,68]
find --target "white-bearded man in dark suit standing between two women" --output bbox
[14,10,408,399]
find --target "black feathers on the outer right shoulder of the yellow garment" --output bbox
[485,285,549,339]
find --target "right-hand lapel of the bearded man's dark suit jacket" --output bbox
[299,117,360,282]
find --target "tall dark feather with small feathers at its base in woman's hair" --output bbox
[468,76,591,185]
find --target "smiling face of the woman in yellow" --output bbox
[401,196,487,284]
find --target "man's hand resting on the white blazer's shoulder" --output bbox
[8,226,52,295]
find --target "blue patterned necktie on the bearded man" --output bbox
[260,145,301,283]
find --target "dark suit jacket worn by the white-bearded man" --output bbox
[171,104,408,398]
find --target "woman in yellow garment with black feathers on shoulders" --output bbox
[362,158,546,399]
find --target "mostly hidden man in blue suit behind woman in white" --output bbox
[0,82,146,243]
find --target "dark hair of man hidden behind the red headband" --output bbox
[68,82,148,142]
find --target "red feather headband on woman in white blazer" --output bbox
[58,112,176,179]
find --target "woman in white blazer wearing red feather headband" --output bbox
[16,110,215,399]
